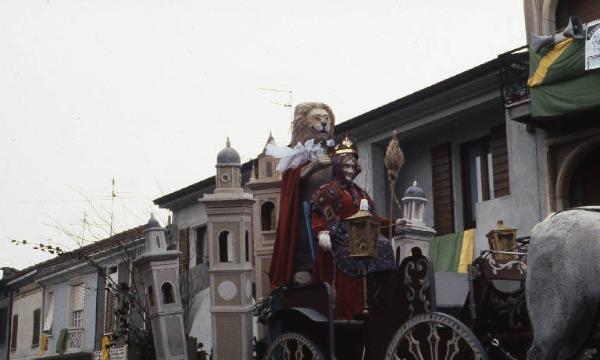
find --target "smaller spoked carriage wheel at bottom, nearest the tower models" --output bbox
[263,332,325,360]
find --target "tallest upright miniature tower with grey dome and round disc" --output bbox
[200,139,254,360]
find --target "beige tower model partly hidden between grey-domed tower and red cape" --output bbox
[246,133,281,339]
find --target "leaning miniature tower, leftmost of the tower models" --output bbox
[135,216,188,360]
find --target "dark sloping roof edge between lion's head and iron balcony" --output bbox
[335,58,498,134]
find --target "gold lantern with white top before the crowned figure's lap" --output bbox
[346,199,379,257]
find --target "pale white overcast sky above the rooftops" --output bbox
[0,0,526,268]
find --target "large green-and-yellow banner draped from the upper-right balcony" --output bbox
[528,39,600,117]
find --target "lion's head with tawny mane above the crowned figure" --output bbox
[290,102,335,146]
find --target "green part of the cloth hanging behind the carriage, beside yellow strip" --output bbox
[429,231,463,272]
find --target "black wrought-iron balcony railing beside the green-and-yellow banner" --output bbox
[498,45,529,107]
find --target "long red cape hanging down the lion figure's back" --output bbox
[269,165,303,288]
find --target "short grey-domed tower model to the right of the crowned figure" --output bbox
[392,181,435,259]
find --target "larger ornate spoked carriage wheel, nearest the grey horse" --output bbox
[385,312,488,360]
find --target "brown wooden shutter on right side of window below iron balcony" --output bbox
[490,125,510,198]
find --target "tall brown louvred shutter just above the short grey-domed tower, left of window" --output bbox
[431,144,454,235]
